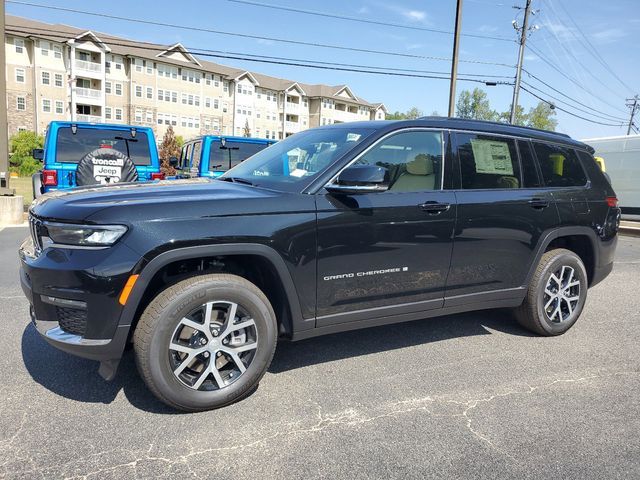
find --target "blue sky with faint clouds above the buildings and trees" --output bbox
[6,0,640,139]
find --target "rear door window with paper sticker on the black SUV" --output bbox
[457,134,520,189]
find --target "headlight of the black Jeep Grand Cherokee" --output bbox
[43,222,127,247]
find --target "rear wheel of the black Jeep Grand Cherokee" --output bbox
[515,248,588,336]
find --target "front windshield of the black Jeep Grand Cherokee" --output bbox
[220,124,374,191]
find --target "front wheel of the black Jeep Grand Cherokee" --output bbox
[133,274,277,411]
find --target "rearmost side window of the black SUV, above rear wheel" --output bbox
[533,142,587,187]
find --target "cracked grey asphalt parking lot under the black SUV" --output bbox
[0,228,640,480]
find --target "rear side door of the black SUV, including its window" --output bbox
[445,133,558,307]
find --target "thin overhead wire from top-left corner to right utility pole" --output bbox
[6,0,513,68]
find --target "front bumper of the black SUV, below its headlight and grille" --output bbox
[20,239,137,379]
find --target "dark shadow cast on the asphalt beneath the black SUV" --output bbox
[22,310,533,414]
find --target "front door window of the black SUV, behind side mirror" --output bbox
[356,131,443,192]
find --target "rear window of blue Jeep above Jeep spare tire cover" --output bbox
[56,127,151,165]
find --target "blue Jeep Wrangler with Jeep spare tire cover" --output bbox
[32,121,164,198]
